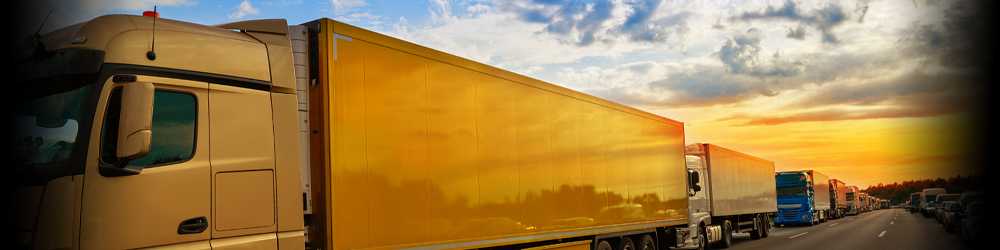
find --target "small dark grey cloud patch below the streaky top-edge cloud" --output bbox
[716,28,802,77]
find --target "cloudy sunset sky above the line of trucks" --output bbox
[23,0,985,187]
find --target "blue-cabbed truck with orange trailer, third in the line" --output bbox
[774,170,831,226]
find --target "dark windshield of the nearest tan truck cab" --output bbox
[13,81,95,184]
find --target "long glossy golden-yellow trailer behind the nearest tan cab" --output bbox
[306,19,687,248]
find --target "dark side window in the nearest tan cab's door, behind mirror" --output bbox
[101,88,198,168]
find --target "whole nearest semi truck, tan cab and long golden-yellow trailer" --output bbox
[15,15,708,249]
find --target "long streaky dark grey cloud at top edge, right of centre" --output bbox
[733,0,847,44]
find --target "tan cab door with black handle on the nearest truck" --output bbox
[80,75,212,249]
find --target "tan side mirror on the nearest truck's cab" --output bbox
[116,82,154,162]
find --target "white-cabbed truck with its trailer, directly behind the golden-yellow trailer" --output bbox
[677,143,777,249]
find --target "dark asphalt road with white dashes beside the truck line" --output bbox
[730,209,969,250]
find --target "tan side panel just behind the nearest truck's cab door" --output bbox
[208,83,278,249]
